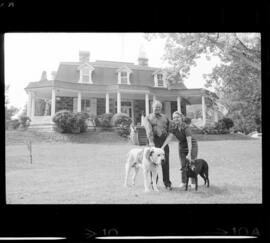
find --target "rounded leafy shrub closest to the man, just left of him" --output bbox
[112,113,132,137]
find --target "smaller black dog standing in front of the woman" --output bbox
[181,159,209,191]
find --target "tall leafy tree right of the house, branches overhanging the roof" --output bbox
[145,33,261,133]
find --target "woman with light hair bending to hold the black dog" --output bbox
[161,111,198,187]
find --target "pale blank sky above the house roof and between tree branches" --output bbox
[4,33,218,109]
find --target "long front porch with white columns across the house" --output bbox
[27,85,217,126]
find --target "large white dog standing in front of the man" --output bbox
[124,147,165,192]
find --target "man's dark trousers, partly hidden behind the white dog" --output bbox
[154,135,172,187]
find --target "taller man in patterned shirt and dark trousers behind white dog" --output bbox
[144,100,172,190]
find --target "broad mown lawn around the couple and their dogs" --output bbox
[6,131,262,204]
